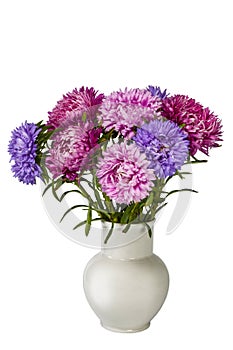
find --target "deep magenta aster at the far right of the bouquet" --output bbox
[161,95,222,156]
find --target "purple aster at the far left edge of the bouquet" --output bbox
[8,121,41,185]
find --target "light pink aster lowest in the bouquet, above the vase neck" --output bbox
[96,142,155,204]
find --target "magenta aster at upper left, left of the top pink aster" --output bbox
[47,87,104,128]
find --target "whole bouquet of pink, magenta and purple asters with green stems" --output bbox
[8,86,222,242]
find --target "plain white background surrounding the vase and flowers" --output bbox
[0,0,233,350]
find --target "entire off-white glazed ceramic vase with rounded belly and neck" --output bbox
[84,222,169,332]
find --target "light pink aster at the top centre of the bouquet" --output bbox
[98,88,161,139]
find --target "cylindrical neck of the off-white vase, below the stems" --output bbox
[101,222,154,260]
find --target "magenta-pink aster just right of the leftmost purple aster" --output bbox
[46,122,102,181]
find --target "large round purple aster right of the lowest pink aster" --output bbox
[133,120,189,178]
